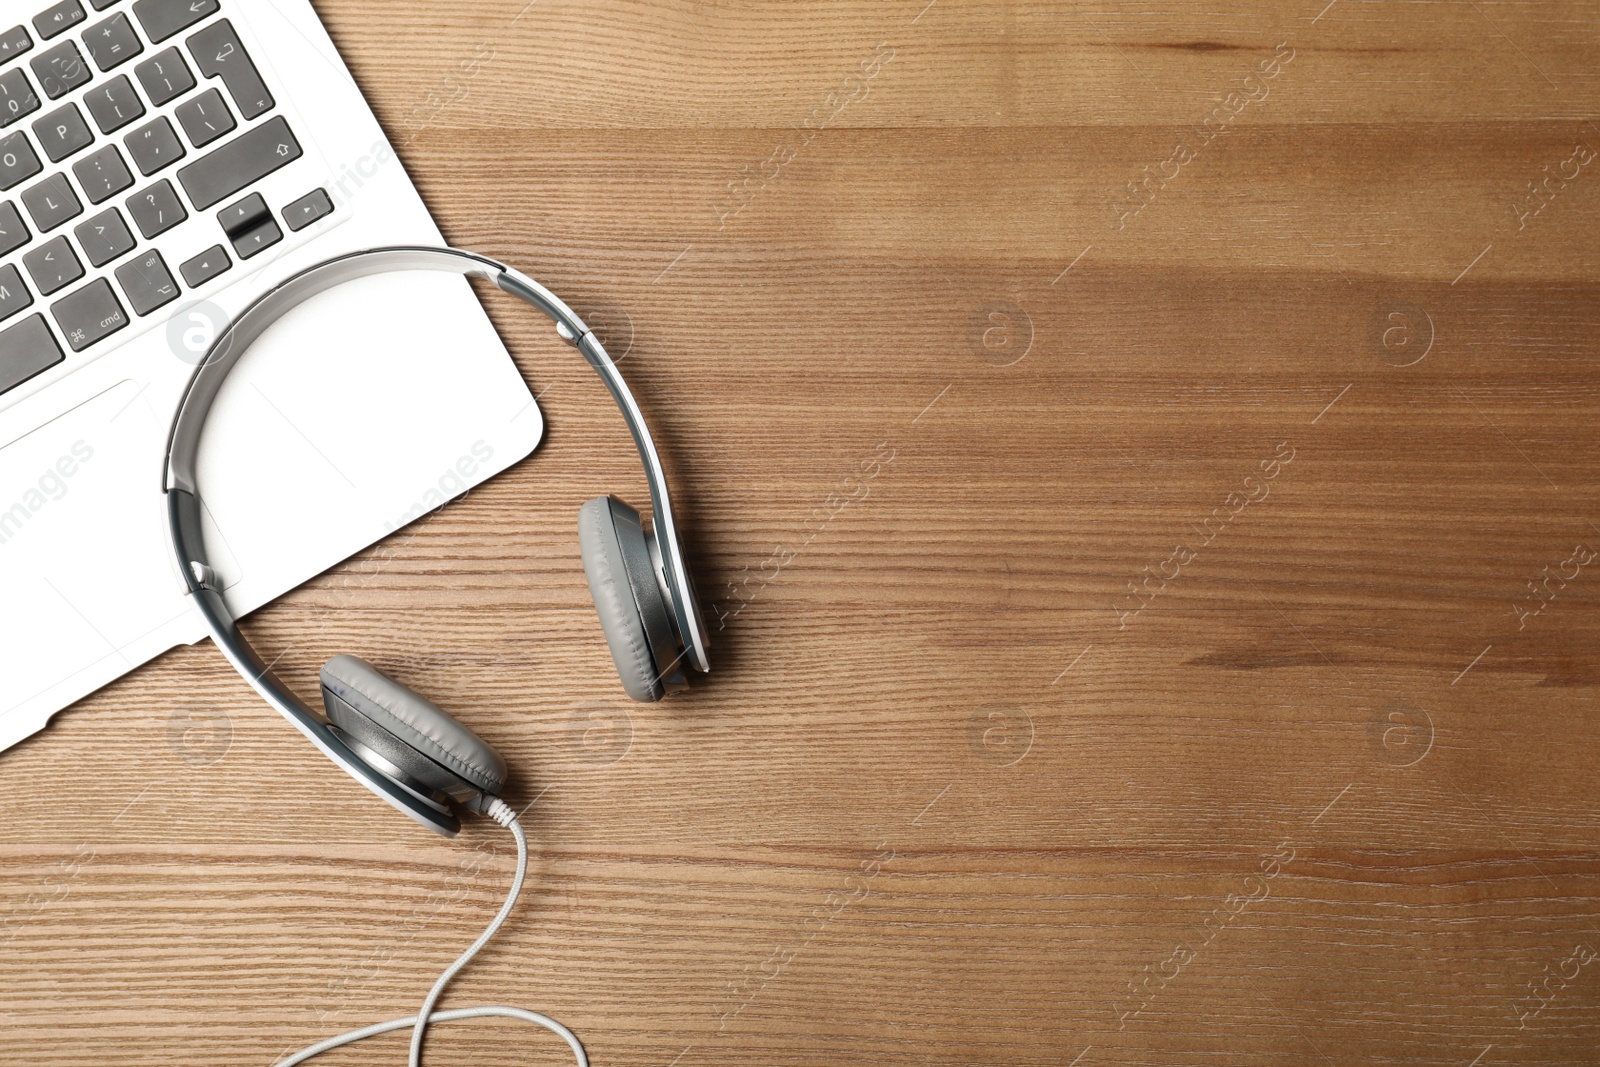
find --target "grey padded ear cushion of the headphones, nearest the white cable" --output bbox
[322,656,506,795]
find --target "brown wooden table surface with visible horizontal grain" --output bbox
[0,0,1600,1067]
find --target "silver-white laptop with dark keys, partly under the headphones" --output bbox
[0,0,542,749]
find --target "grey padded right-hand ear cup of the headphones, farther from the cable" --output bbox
[578,496,685,701]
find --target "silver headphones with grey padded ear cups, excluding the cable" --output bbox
[163,248,710,837]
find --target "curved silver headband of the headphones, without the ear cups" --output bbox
[163,246,710,835]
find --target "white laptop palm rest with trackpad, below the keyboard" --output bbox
[0,274,544,750]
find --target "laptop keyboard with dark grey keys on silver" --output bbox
[0,0,334,394]
